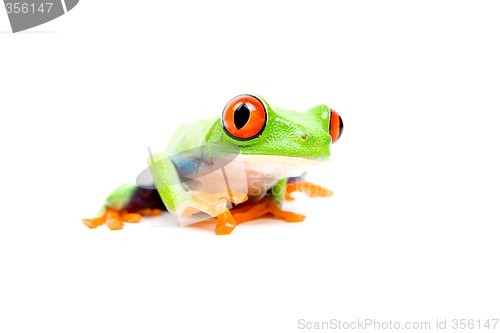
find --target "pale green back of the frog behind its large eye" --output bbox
[166,118,220,154]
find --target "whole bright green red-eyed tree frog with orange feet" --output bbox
[83,94,344,235]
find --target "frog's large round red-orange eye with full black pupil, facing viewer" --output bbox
[222,95,267,140]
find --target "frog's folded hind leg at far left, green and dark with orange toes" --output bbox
[83,184,166,230]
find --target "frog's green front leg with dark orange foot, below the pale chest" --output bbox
[231,178,305,223]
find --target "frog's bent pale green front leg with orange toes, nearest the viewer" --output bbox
[149,153,247,235]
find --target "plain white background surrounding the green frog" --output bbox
[0,0,500,333]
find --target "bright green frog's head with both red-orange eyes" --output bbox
[209,95,343,160]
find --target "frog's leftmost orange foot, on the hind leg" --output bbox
[83,208,162,230]
